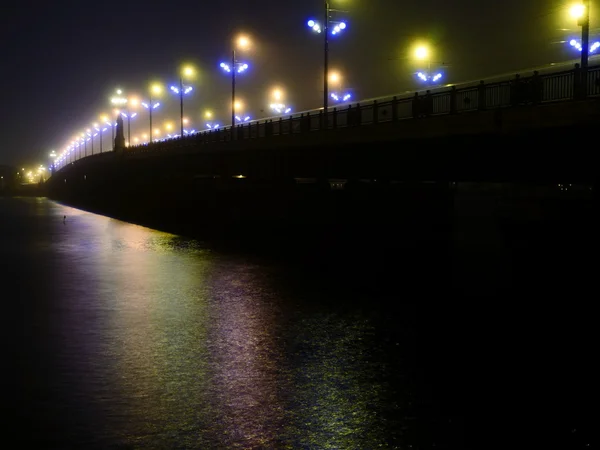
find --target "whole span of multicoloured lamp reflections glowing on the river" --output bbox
[0,200,418,449]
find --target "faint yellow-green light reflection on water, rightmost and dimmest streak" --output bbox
[287,314,385,449]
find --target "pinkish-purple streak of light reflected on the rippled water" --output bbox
[206,265,285,448]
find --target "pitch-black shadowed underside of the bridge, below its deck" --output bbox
[48,103,598,256]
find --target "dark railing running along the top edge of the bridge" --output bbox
[55,65,600,166]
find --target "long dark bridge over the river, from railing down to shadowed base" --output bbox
[47,62,600,239]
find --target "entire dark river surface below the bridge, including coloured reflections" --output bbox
[0,198,597,449]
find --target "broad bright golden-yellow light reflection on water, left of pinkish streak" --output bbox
[89,221,212,448]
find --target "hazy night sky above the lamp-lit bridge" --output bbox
[0,0,594,165]
